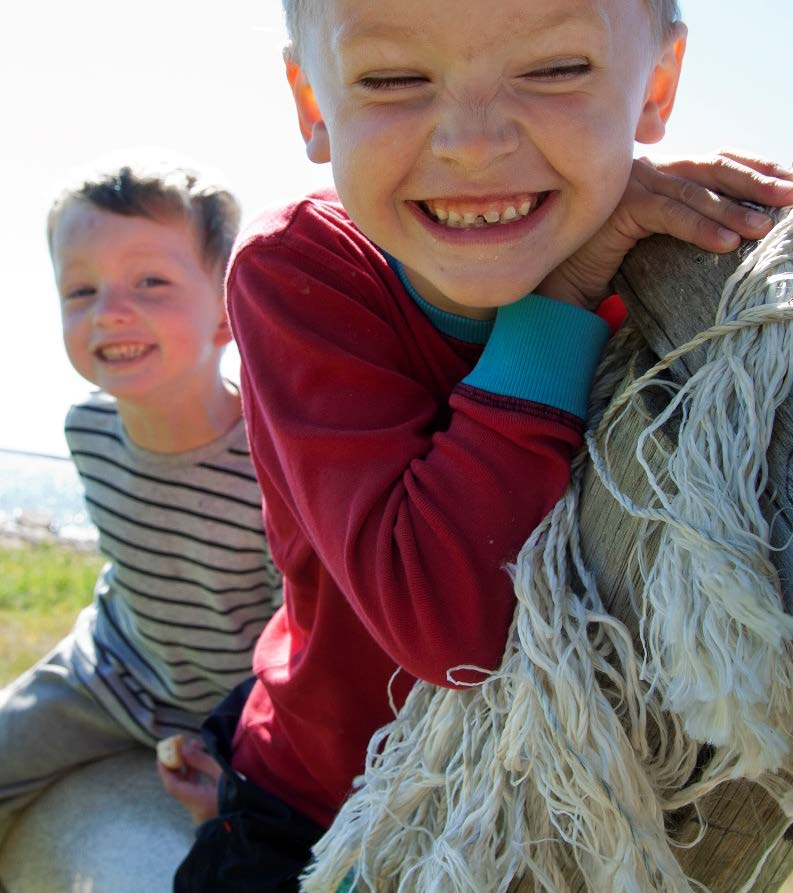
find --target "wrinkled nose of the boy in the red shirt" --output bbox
[432,99,520,172]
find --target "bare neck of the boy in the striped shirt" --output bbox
[117,374,241,453]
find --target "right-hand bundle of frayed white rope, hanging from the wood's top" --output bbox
[587,212,793,778]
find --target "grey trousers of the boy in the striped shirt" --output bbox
[0,635,139,843]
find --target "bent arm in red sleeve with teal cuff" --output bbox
[228,233,608,685]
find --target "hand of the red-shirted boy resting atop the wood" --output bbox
[537,152,793,308]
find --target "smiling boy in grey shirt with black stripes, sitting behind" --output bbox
[0,155,281,839]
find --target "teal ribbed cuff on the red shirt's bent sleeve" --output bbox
[463,295,610,419]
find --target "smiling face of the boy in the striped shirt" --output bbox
[52,201,229,408]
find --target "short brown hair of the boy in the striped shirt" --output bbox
[47,157,240,271]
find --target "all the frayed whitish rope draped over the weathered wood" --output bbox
[303,209,793,893]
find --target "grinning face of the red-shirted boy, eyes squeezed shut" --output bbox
[292,0,676,316]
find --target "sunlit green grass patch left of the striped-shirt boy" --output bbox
[0,545,103,686]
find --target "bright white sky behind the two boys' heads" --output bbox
[0,0,793,454]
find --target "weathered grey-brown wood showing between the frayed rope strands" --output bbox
[515,237,793,893]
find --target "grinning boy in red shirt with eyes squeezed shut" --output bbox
[170,0,793,893]
